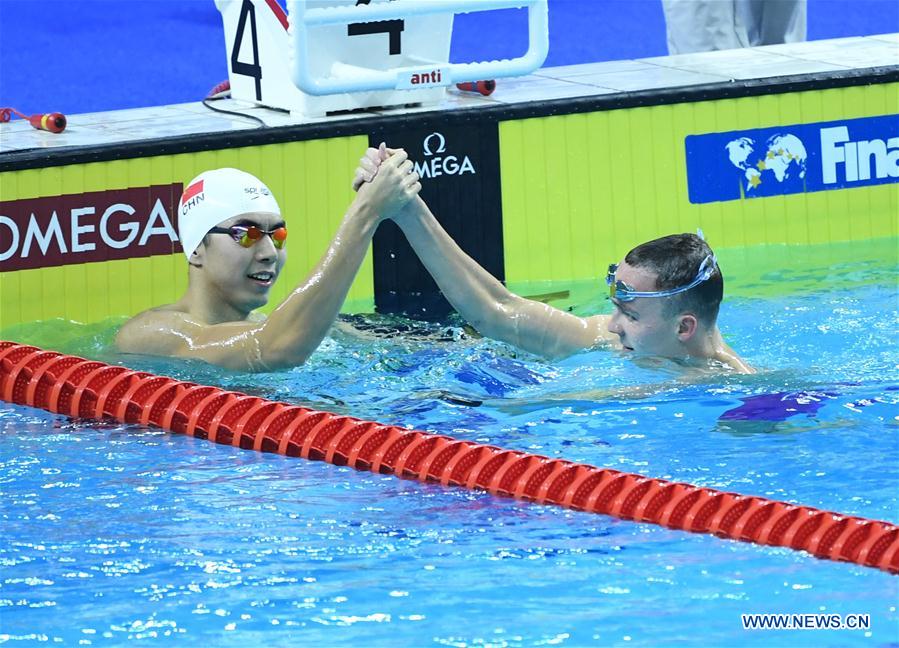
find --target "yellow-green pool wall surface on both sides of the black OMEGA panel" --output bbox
[0,83,899,331]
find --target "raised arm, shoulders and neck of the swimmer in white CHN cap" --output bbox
[116,152,421,371]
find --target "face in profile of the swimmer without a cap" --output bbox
[608,261,688,358]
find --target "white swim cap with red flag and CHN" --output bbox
[178,169,281,260]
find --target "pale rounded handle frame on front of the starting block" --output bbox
[288,0,549,96]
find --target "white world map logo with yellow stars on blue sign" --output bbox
[724,133,808,192]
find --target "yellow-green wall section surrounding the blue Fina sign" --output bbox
[500,84,899,292]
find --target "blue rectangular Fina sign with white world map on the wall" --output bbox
[684,115,899,203]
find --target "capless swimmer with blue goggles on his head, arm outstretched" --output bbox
[353,144,752,373]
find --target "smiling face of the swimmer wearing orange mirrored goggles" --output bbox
[200,212,287,315]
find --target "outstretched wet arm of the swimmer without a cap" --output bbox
[394,197,607,358]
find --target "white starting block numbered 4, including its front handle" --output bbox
[215,0,549,116]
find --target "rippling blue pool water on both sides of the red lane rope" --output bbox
[0,241,899,646]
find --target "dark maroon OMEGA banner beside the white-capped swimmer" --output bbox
[0,183,182,272]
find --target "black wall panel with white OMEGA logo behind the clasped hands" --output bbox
[369,122,505,320]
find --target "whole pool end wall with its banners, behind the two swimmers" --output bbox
[0,67,899,329]
